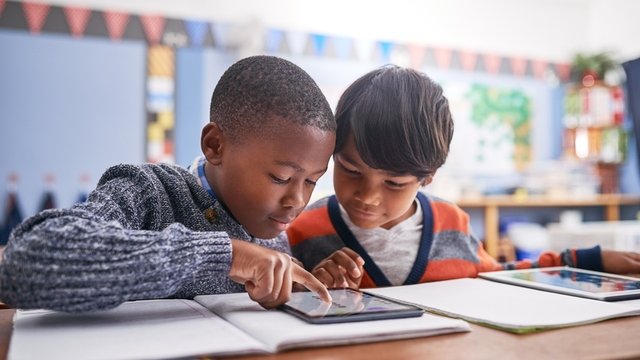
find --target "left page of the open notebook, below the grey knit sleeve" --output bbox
[8,300,264,360]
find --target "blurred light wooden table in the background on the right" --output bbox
[456,194,640,258]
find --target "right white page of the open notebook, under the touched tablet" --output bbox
[195,293,470,352]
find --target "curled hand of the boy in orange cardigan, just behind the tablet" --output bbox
[312,247,364,289]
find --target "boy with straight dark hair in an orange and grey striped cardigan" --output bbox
[287,66,640,288]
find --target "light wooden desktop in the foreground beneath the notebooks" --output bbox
[0,310,640,360]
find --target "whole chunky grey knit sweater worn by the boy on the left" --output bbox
[0,164,290,312]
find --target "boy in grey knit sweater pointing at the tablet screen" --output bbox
[0,56,336,312]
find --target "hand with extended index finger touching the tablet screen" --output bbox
[229,240,331,309]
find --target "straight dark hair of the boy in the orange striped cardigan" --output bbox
[334,65,453,179]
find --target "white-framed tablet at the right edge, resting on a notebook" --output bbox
[478,266,640,301]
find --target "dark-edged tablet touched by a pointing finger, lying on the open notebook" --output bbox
[281,289,424,324]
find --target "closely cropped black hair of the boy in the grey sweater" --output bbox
[209,55,336,141]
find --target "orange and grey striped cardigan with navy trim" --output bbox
[287,192,602,288]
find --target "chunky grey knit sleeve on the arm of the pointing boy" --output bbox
[0,170,231,312]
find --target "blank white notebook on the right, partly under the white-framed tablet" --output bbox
[367,278,640,333]
